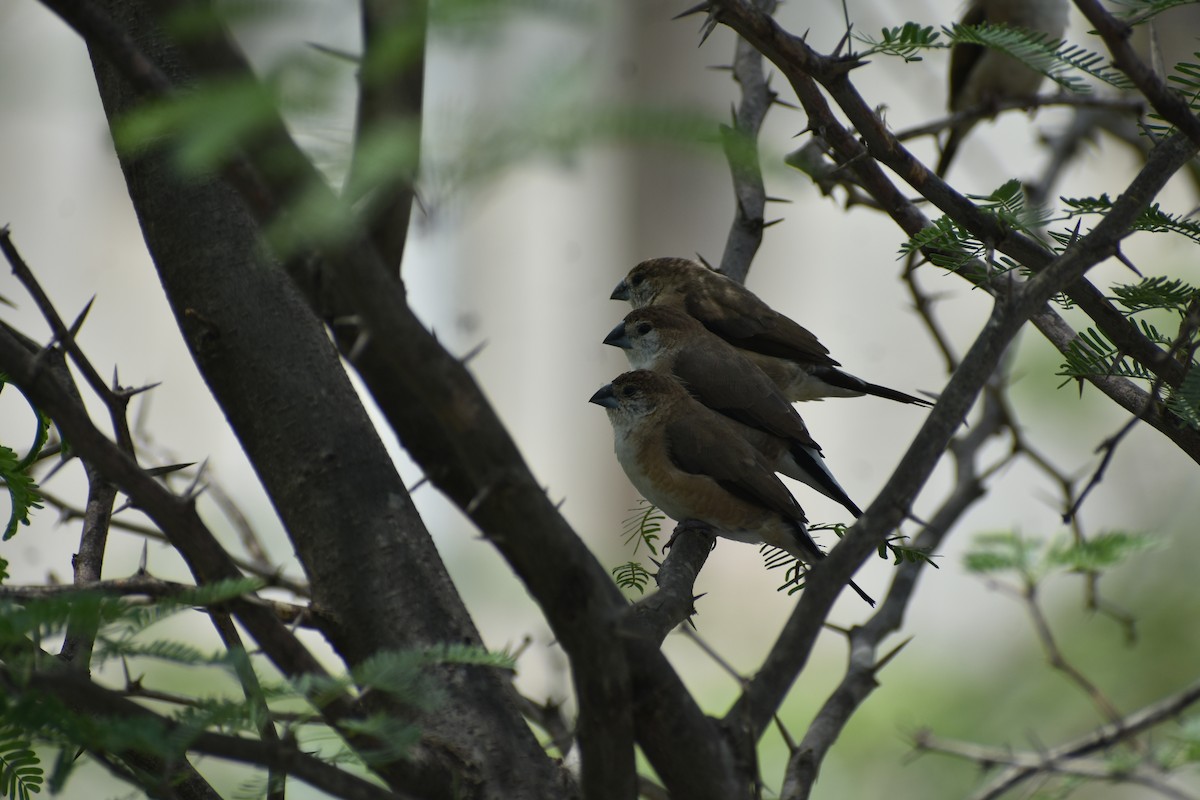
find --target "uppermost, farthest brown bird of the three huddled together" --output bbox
[610,258,932,407]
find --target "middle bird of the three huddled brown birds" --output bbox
[604,306,863,517]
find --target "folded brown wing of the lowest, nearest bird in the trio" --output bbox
[662,405,804,522]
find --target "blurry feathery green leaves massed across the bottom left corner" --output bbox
[0,579,515,800]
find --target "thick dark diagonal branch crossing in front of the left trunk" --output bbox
[32,0,744,798]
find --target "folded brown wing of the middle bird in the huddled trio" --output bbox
[672,342,821,450]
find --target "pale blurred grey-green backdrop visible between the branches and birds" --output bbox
[0,0,1200,799]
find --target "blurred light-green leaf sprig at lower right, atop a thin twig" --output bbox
[964,531,1156,584]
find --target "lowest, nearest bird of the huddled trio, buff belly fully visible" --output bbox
[589,369,875,606]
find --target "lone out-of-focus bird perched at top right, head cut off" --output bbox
[936,0,1067,178]
